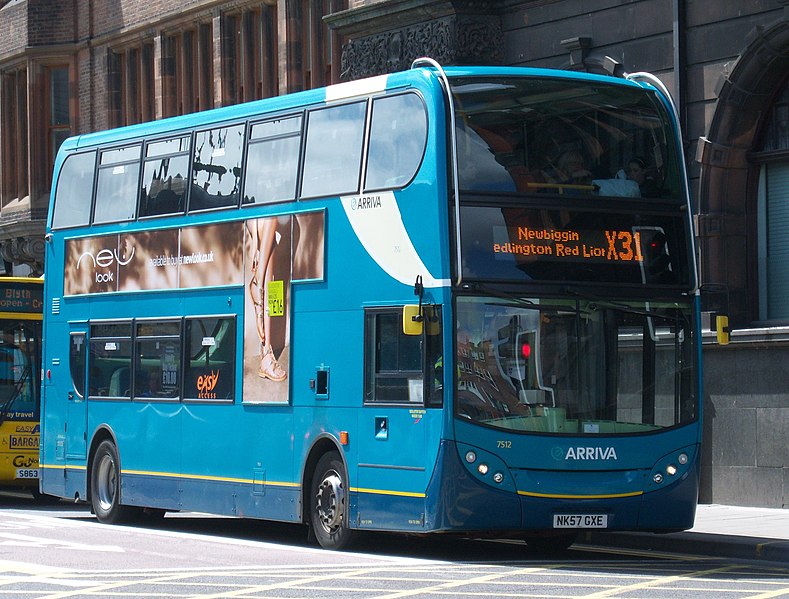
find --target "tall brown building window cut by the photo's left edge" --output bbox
[0,69,30,206]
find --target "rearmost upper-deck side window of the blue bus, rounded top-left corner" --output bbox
[52,152,96,229]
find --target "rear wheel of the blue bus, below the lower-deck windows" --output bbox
[90,441,141,524]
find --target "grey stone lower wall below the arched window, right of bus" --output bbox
[700,338,789,508]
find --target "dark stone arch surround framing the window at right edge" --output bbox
[697,22,789,328]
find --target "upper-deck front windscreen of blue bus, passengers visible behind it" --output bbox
[452,77,683,200]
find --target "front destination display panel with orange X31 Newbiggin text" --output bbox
[460,206,688,285]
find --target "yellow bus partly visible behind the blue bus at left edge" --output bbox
[0,277,44,496]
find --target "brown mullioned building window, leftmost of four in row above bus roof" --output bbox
[107,42,156,127]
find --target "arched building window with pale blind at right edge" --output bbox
[754,84,789,321]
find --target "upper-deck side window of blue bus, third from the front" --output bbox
[243,115,302,204]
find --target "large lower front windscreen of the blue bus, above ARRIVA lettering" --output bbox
[455,296,697,435]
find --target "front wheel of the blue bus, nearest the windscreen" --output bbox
[309,451,356,550]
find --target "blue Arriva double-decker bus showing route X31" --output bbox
[41,59,701,548]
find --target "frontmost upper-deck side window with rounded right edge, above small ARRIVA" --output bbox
[364,94,427,191]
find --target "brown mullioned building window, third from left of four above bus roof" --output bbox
[222,6,278,105]
